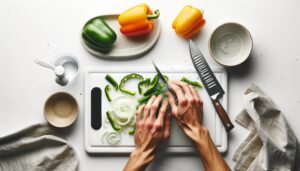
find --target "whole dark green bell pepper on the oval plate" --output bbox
[82,18,117,52]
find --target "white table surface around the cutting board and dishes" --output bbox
[0,0,300,170]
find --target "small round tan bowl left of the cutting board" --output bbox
[44,92,79,128]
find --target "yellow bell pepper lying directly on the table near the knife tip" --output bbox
[172,5,206,38]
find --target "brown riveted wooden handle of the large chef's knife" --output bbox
[212,98,234,132]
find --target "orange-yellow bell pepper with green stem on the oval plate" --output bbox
[119,3,160,36]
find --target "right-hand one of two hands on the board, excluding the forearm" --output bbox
[167,81,206,142]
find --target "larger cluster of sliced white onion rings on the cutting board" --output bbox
[112,96,137,126]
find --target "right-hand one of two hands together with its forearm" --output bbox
[167,81,230,171]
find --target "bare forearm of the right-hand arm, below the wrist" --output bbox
[195,128,230,171]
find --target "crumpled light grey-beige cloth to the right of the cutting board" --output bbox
[233,84,300,171]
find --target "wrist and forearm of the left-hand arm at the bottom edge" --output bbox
[124,150,154,171]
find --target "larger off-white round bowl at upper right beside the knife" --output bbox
[208,23,253,66]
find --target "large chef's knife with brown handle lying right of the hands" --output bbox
[189,40,234,132]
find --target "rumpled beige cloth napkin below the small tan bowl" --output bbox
[0,124,78,171]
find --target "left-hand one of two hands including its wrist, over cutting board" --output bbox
[124,95,170,171]
